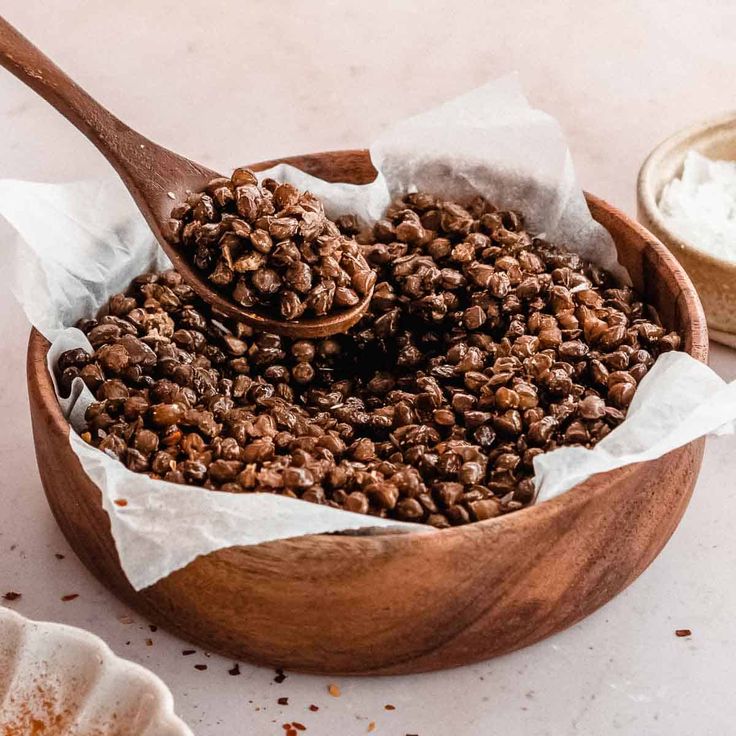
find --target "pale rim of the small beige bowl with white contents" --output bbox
[636,111,736,279]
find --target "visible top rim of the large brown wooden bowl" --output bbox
[28,150,708,554]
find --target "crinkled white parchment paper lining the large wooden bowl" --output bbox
[0,77,736,589]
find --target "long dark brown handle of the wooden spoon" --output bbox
[0,17,214,226]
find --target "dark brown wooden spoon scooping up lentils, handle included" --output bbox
[0,17,373,338]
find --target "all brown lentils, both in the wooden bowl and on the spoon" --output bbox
[58,175,680,527]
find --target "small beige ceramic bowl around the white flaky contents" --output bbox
[637,113,736,347]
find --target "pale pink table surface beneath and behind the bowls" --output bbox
[0,0,736,736]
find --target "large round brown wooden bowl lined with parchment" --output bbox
[28,151,708,674]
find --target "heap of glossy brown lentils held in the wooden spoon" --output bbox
[167,169,376,321]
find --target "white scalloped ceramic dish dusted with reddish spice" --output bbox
[0,607,193,736]
